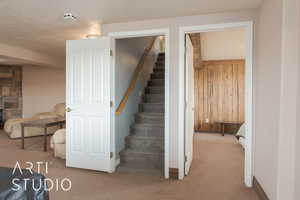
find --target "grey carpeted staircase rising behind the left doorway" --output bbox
[118,53,165,175]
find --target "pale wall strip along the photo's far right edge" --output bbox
[277,0,300,200]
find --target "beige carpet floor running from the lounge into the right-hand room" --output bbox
[0,132,259,200]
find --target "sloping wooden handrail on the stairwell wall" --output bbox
[116,37,156,115]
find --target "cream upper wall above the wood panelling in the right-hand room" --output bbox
[200,28,246,60]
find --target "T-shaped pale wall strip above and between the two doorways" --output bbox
[102,10,257,168]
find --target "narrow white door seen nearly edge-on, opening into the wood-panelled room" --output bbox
[185,35,194,175]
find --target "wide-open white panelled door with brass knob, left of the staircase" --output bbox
[66,37,114,172]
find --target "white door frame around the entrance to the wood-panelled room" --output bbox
[178,21,254,187]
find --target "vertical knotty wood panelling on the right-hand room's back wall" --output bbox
[195,60,245,132]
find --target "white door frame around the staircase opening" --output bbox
[108,28,170,179]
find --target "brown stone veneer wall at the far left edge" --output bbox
[0,66,23,121]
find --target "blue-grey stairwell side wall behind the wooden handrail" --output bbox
[115,37,157,156]
